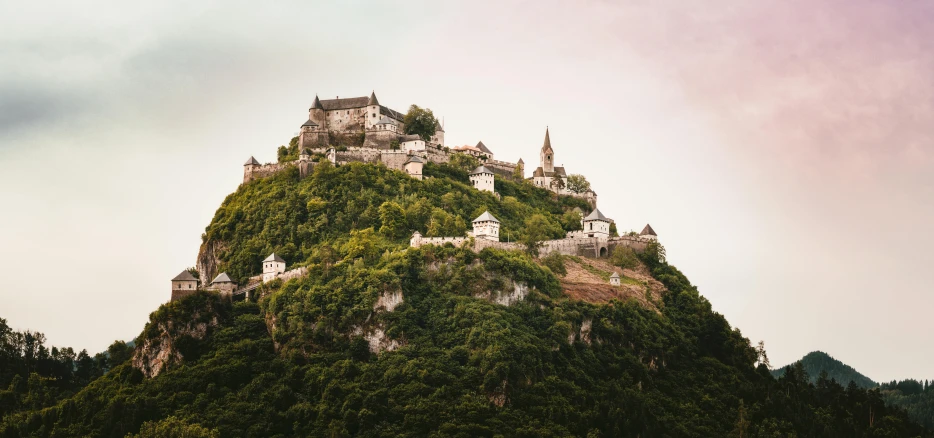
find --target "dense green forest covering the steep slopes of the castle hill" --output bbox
[0,160,934,437]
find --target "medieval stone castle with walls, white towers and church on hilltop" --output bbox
[172,91,657,301]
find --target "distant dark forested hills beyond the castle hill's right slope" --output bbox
[772,351,934,430]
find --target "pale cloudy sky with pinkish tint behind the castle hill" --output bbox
[0,0,934,381]
